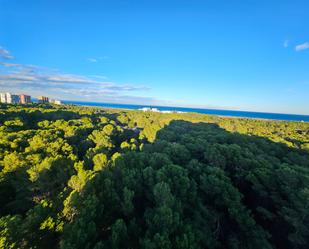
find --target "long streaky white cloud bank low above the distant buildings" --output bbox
[0,59,149,99]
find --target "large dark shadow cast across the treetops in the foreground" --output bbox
[0,119,309,248]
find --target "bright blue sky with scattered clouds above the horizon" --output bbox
[0,0,309,115]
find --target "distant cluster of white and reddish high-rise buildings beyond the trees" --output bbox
[0,93,62,105]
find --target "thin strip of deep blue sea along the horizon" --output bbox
[62,100,309,122]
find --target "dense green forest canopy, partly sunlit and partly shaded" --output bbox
[0,104,309,249]
